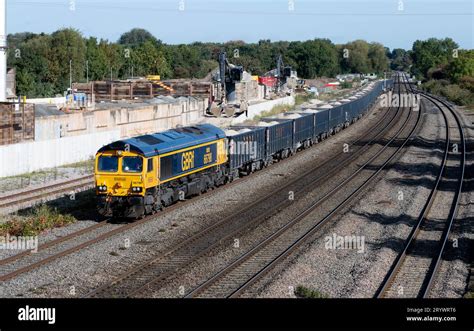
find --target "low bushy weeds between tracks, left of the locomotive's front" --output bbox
[0,205,77,237]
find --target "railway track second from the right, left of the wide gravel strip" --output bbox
[185,77,421,298]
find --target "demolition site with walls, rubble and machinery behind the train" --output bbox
[0,43,308,177]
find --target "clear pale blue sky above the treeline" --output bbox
[6,0,474,49]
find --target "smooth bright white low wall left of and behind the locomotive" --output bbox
[0,130,120,177]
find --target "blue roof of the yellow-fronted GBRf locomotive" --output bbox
[99,124,225,157]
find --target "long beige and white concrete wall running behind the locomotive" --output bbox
[0,99,207,177]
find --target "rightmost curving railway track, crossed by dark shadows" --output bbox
[376,89,466,298]
